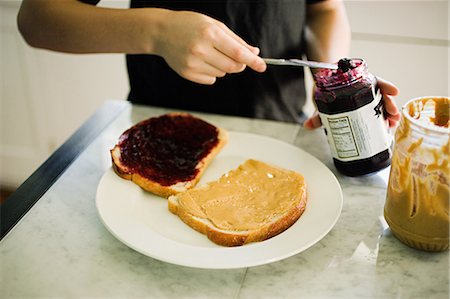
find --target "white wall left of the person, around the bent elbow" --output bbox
[0,0,128,187]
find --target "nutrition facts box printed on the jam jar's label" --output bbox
[328,116,359,158]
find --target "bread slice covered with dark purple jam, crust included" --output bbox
[110,112,228,198]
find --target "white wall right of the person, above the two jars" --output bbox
[345,0,450,106]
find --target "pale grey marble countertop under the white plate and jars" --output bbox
[0,101,449,299]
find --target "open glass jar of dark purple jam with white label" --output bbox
[314,59,392,176]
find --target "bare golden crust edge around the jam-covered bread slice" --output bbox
[110,112,228,198]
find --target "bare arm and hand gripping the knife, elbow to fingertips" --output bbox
[17,0,266,84]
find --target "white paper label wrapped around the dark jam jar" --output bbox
[320,90,392,162]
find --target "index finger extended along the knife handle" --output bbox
[213,27,266,72]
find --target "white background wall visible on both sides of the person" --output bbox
[0,0,450,187]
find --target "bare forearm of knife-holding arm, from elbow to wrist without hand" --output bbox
[18,0,168,54]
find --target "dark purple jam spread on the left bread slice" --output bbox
[119,114,219,186]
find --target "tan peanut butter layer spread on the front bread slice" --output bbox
[177,160,306,231]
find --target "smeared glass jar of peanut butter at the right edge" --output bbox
[384,97,450,251]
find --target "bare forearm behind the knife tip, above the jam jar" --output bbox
[305,0,351,62]
